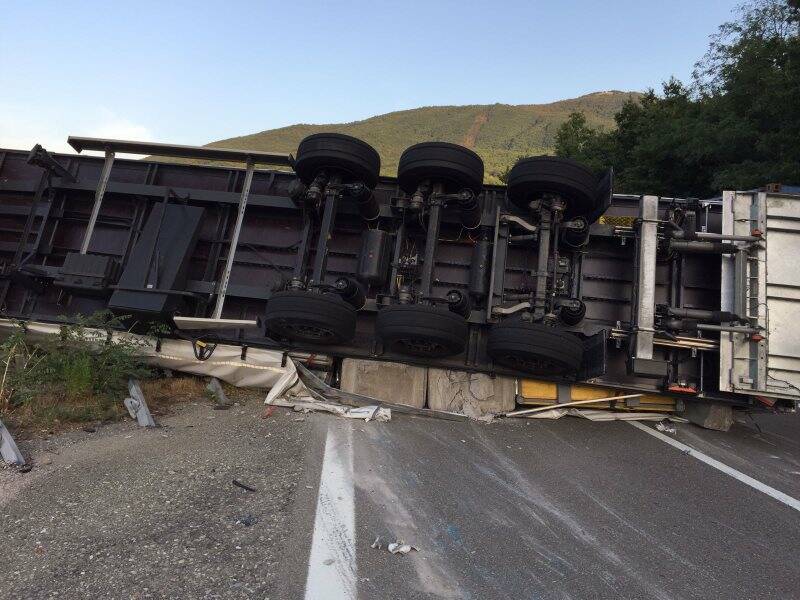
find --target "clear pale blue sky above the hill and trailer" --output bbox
[0,0,739,150]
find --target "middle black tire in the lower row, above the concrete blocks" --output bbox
[375,304,468,358]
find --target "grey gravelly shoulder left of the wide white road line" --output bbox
[0,398,307,598]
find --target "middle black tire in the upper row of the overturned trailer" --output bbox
[397,142,483,196]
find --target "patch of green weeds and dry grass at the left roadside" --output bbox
[0,311,153,431]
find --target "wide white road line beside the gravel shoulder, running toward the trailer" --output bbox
[305,425,357,600]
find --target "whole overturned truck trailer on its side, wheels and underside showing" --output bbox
[0,133,800,409]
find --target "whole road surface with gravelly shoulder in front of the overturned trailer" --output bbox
[0,396,800,600]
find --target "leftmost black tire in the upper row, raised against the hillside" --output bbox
[294,133,381,189]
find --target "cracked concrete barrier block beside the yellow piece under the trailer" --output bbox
[428,368,516,417]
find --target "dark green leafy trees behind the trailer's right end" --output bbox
[556,0,800,197]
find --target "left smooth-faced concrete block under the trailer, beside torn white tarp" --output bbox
[341,358,428,408]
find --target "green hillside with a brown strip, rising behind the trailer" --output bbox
[198,91,639,183]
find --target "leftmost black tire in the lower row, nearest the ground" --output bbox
[264,291,356,344]
